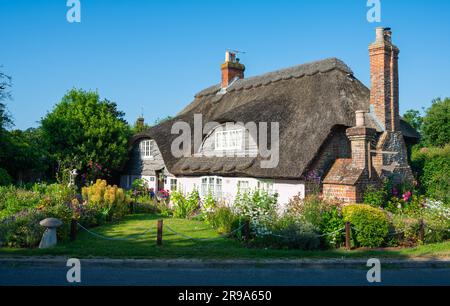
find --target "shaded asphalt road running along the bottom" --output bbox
[0,262,450,286]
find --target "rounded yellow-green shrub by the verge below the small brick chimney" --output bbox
[342,204,389,247]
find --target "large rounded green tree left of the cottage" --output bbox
[41,89,131,183]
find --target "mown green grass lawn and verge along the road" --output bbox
[0,214,450,259]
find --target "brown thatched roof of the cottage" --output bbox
[134,58,420,179]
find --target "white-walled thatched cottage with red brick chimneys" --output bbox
[121,28,419,204]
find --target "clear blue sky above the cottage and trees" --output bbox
[0,0,450,129]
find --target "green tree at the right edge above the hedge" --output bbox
[422,98,450,147]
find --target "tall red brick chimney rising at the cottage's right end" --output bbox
[369,28,400,131]
